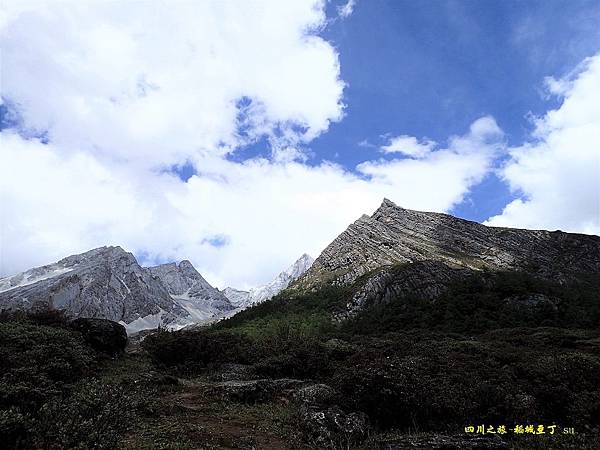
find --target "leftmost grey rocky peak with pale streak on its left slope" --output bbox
[0,247,187,323]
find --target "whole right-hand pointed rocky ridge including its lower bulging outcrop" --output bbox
[291,199,600,320]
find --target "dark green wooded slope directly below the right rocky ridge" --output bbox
[344,272,600,335]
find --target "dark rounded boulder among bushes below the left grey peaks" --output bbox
[70,318,127,355]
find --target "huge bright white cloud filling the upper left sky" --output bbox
[1,0,344,166]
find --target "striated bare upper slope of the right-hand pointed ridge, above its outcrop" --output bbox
[298,199,600,288]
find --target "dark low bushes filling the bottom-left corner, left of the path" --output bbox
[0,312,152,449]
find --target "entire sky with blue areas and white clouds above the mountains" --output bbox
[0,0,600,287]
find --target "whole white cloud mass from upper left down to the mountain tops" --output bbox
[0,1,502,287]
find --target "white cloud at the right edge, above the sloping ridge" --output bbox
[487,54,600,234]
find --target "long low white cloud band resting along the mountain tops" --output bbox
[0,114,500,287]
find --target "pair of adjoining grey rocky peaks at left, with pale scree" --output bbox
[0,247,234,333]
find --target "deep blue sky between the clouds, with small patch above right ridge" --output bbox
[318,0,600,222]
